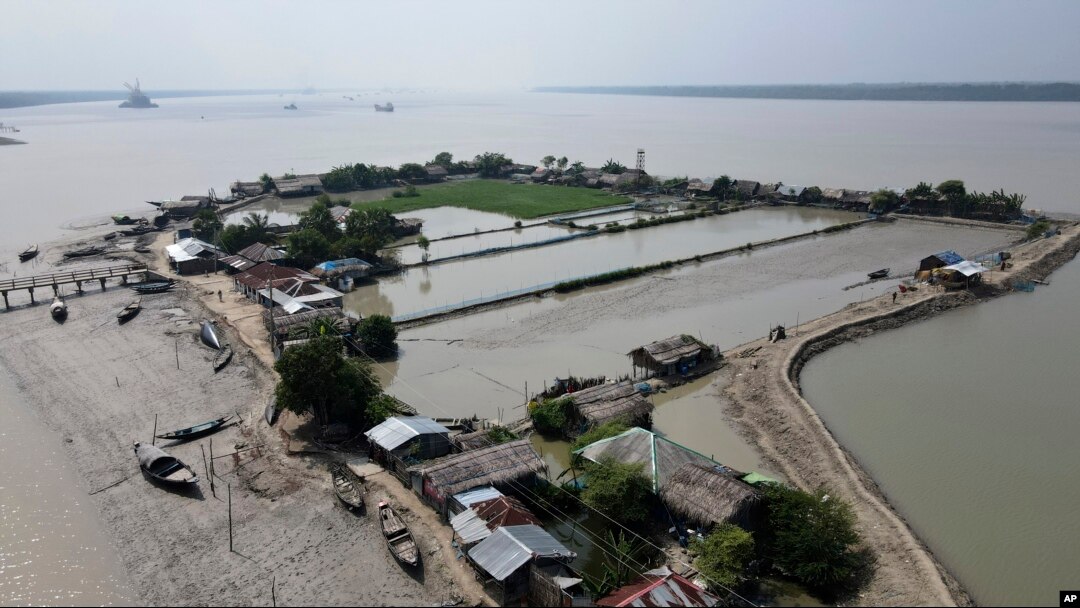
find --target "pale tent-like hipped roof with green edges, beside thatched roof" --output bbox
[573,428,721,494]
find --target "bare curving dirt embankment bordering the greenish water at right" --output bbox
[723,225,1080,606]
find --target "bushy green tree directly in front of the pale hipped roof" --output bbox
[581,456,652,524]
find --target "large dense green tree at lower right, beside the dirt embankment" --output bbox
[764,484,866,591]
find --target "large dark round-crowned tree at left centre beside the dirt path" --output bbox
[274,335,381,425]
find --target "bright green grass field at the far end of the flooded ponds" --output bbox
[356,179,630,219]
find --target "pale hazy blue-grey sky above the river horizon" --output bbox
[0,0,1080,92]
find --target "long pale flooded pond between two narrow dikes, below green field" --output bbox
[345,207,859,316]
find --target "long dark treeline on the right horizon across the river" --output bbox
[532,82,1080,102]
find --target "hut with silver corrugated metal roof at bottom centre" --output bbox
[468,525,578,606]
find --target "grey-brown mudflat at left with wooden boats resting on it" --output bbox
[0,274,477,606]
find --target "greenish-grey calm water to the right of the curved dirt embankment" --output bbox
[801,261,1080,606]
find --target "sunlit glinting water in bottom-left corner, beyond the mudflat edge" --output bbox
[0,368,134,606]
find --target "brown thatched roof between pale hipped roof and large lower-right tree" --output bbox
[660,462,760,524]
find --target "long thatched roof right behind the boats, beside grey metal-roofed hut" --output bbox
[409,440,548,497]
